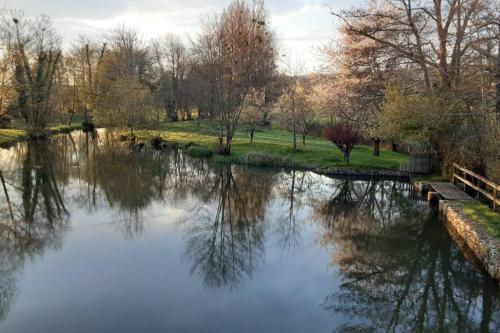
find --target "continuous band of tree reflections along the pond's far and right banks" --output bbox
[0,132,500,332]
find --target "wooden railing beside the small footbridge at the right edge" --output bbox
[453,163,500,211]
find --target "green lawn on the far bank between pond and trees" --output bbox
[137,121,408,170]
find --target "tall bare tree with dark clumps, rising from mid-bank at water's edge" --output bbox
[195,0,275,155]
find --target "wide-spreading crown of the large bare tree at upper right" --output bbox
[332,0,488,91]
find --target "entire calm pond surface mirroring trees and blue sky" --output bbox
[0,133,500,332]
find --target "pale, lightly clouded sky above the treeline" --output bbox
[0,0,360,72]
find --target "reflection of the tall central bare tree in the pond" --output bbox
[182,166,273,288]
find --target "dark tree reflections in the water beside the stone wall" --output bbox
[315,181,500,332]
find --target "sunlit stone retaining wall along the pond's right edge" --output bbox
[439,200,500,283]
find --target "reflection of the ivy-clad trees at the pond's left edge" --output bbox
[0,142,69,318]
